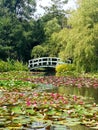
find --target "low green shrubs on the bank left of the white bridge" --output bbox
[0,60,28,72]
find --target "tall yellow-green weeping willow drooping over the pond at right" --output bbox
[61,0,98,72]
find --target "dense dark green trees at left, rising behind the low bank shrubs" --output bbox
[0,0,44,62]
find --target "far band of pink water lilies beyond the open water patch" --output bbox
[30,76,98,88]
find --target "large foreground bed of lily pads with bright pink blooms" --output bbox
[0,90,98,129]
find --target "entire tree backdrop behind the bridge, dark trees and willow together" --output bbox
[0,0,98,72]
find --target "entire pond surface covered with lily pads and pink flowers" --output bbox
[0,71,98,130]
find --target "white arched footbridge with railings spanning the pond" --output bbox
[28,57,64,70]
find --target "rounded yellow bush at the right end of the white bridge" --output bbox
[56,64,75,76]
